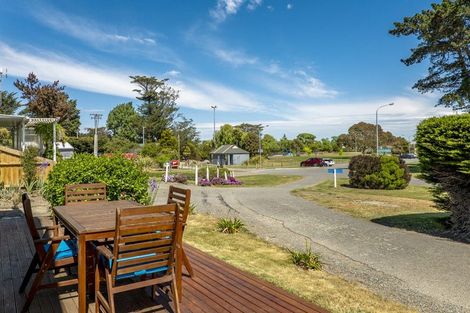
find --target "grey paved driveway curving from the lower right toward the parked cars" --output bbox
[165,168,470,312]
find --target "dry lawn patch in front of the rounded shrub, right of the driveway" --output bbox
[293,179,449,235]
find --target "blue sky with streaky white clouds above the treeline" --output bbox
[0,0,449,138]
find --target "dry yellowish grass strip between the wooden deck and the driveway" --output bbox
[185,214,416,313]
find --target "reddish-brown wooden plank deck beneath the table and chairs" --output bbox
[0,211,326,313]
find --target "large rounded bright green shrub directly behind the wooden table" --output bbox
[44,154,149,206]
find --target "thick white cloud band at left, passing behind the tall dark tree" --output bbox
[0,42,263,112]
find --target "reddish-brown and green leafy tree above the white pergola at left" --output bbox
[14,73,80,135]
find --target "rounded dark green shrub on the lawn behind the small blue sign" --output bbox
[349,155,411,189]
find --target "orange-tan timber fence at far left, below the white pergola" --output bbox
[0,146,54,186]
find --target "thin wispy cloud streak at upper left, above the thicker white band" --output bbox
[31,7,182,65]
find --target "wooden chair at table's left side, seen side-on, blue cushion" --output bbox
[19,193,78,313]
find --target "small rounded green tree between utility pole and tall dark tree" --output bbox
[106,102,141,142]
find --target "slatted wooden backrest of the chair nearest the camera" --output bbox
[111,204,180,283]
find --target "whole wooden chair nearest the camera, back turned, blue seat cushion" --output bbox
[95,204,181,313]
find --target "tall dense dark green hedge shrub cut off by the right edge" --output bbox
[416,113,470,236]
